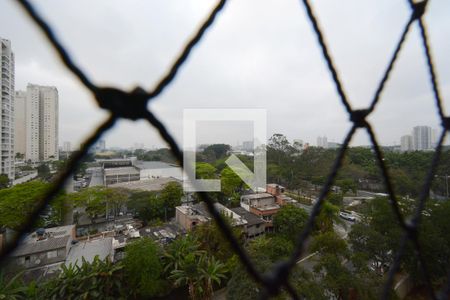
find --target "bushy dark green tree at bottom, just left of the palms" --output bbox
[123,237,169,298]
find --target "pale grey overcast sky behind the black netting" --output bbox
[0,0,450,147]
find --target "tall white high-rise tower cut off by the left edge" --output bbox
[0,37,14,180]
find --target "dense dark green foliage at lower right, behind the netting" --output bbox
[349,198,450,286]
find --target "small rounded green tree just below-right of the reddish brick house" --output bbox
[273,204,308,241]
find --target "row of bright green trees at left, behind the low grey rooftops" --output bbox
[0,180,183,230]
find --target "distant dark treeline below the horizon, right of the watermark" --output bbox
[267,134,450,197]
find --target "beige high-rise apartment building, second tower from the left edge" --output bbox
[15,84,59,162]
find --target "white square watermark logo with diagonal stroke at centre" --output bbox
[183,109,267,192]
